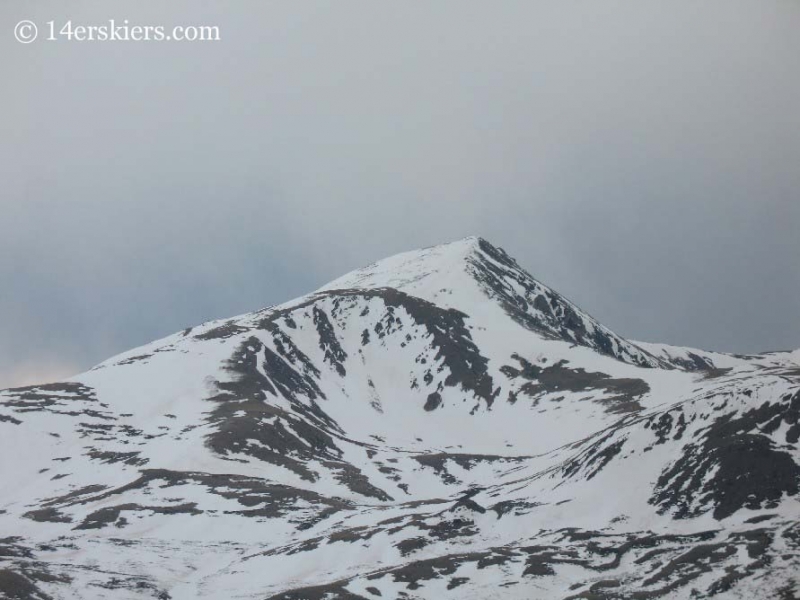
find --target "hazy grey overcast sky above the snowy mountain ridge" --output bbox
[0,0,800,387]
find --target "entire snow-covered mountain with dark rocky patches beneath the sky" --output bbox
[0,238,800,600]
